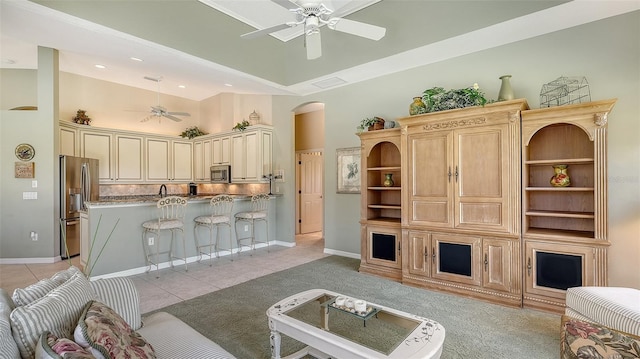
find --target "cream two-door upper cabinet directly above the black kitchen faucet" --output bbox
[146,137,193,182]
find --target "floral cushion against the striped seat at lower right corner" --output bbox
[560,315,640,359]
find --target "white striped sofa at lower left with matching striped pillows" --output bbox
[0,267,234,359]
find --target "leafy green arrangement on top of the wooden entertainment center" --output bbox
[422,83,487,112]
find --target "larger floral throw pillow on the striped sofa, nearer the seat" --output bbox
[74,301,156,359]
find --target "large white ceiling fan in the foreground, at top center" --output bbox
[240,0,387,60]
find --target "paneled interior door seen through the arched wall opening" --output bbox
[299,152,323,233]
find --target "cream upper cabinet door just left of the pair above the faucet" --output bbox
[116,135,144,182]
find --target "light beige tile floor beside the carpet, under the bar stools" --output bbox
[0,232,326,313]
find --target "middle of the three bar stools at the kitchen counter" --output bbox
[193,194,238,266]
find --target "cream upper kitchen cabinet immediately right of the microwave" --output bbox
[231,126,272,183]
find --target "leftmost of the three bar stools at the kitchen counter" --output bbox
[142,196,189,272]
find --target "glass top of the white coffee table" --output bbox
[283,294,420,355]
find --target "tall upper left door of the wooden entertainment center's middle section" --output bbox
[406,131,453,227]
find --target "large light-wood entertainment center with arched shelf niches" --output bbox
[359,99,615,312]
